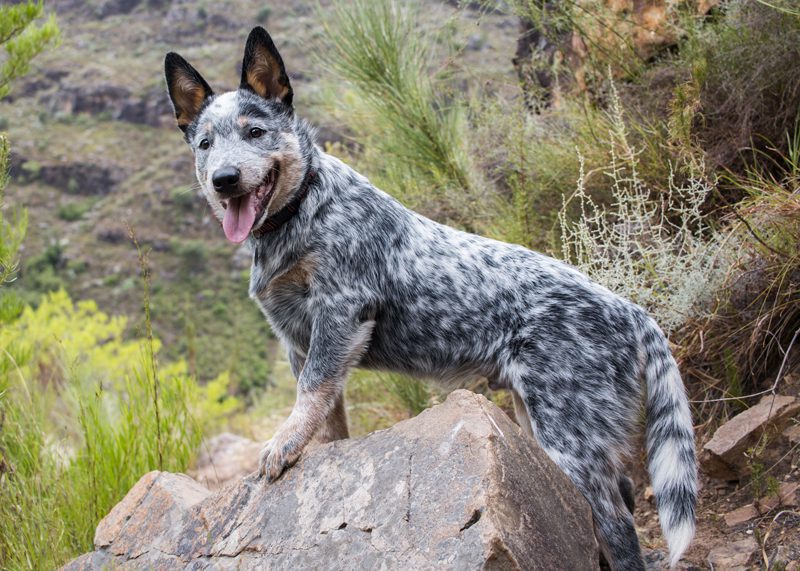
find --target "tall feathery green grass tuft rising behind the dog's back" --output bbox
[321,0,481,225]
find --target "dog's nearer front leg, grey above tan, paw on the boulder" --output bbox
[259,317,374,481]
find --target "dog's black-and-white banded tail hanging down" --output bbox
[639,313,697,566]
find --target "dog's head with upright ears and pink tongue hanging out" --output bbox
[164,27,304,243]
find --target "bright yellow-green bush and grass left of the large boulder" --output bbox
[0,292,238,569]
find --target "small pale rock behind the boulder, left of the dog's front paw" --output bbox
[191,432,263,490]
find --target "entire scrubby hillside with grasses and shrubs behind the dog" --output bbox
[0,0,800,569]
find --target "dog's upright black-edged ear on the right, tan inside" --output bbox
[239,27,294,107]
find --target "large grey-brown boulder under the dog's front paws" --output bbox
[65,390,598,569]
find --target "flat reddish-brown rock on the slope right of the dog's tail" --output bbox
[701,395,800,480]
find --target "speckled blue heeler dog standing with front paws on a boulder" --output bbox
[165,28,697,569]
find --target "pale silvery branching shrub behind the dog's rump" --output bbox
[560,85,724,334]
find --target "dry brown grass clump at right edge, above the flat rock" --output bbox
[684,139,800,404]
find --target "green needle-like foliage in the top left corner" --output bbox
[0,0,59,99]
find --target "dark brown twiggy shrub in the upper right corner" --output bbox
[681,0,800,174]
